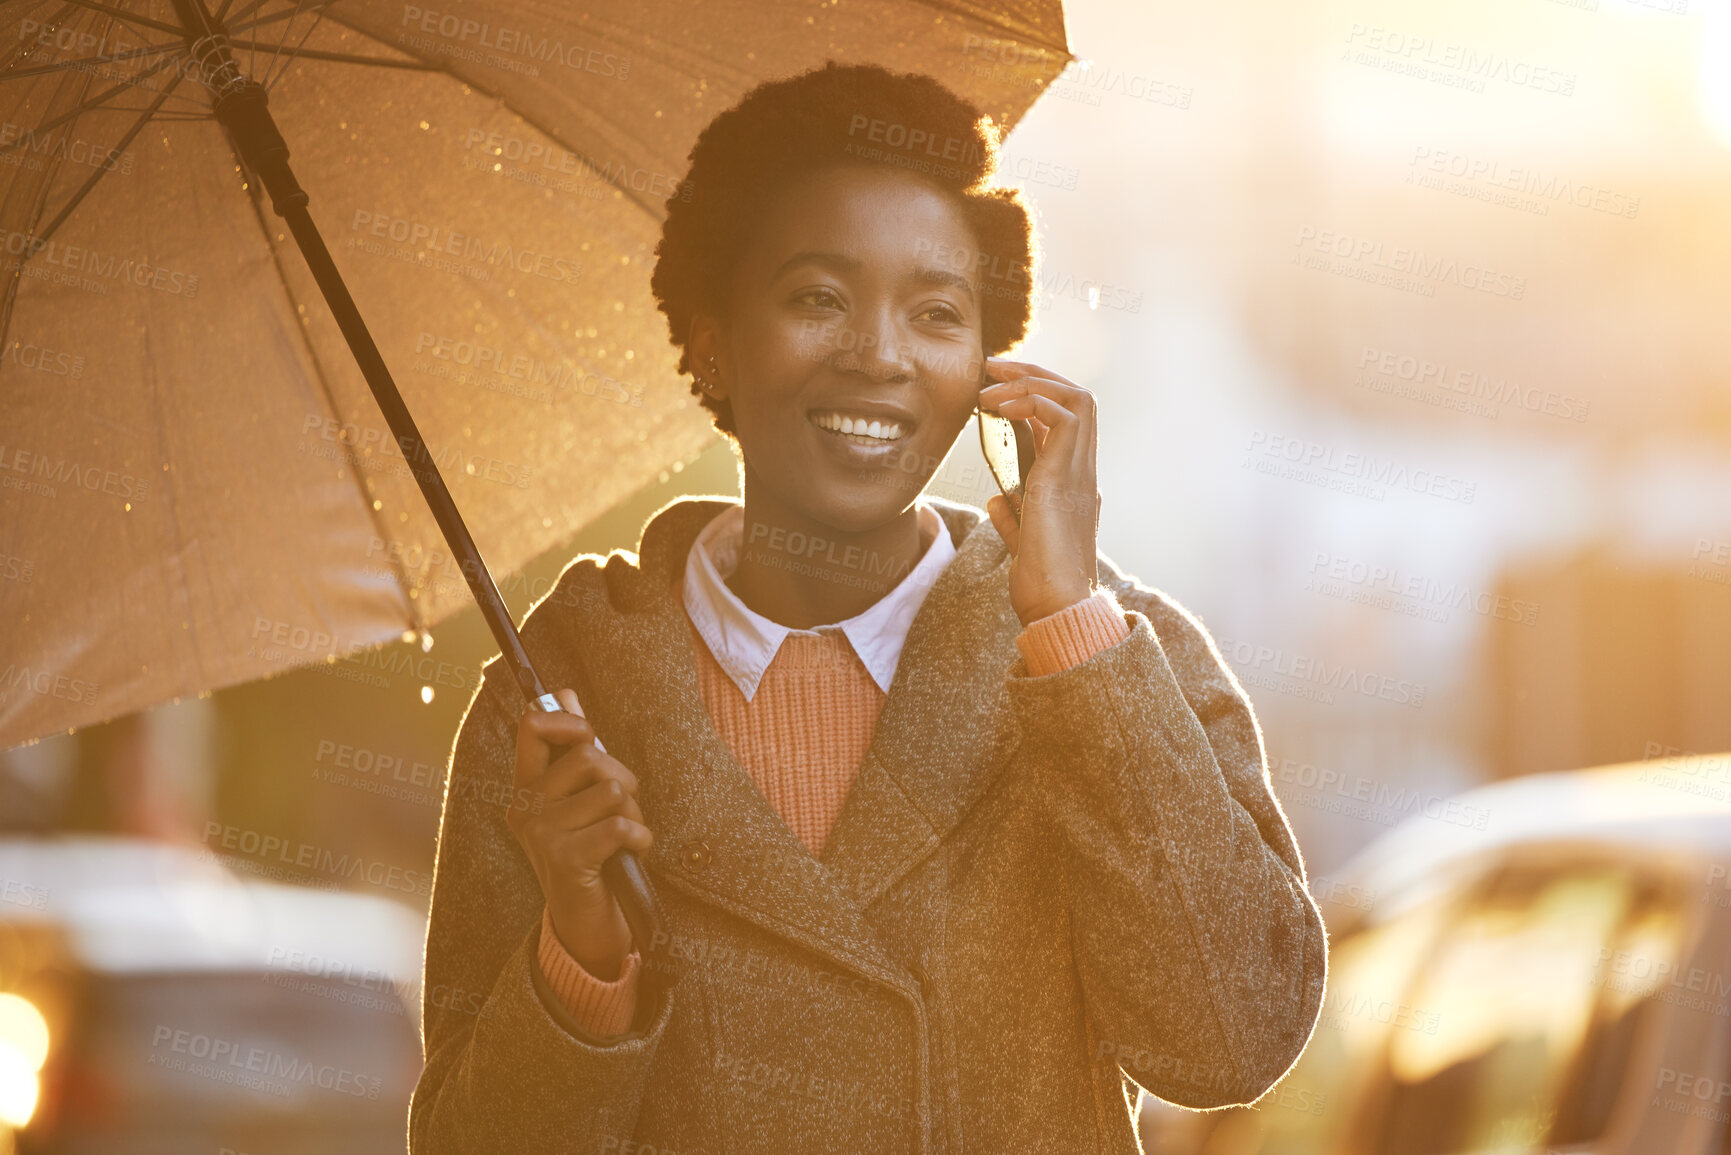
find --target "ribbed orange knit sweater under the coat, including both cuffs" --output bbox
[538,590,1130,1037]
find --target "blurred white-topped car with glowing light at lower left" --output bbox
[0,838,426,1155]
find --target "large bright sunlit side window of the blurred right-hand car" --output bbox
[1373,866,1676,1155]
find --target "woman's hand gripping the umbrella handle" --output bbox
[505,689,654,982]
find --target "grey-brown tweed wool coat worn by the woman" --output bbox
[410,499,1328,1155]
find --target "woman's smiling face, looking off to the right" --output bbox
[694,165,983,532]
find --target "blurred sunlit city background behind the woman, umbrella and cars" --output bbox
[0,0,1731,1153]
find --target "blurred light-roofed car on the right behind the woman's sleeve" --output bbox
[1139,755,1731,1155]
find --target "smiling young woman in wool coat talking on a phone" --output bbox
[410,64,1328,1155]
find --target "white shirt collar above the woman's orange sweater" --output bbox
[684,502,956,701]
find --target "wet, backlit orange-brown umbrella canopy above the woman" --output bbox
[0,0,1070,748]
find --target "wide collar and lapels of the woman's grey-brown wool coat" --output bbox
[549,499,1020,987]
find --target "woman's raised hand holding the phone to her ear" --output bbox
[980,357,1099,625]
